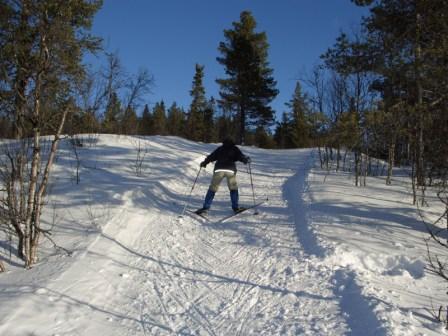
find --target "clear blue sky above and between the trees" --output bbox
[87,0,366,115]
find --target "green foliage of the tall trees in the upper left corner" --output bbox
[0,0,102,138]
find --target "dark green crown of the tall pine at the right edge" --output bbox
[364,0,448,176]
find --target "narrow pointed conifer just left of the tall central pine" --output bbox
[187,64,207,141]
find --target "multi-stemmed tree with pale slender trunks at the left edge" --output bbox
[0,0,101,268]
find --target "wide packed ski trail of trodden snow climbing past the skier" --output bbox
[0,137,386,336]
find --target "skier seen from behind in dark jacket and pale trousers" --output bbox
[195,138,250,215]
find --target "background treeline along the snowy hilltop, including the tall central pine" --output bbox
[0,8,316,148]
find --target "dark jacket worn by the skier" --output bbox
[201,141,249,173]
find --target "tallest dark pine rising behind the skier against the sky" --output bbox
[217,11,278,143]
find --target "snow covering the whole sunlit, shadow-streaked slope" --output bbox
[0,135,446,336]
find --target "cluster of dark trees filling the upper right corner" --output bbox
[323,0,448,190]
